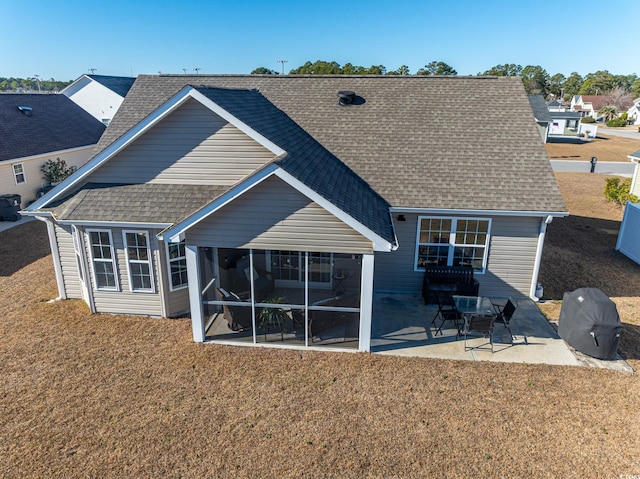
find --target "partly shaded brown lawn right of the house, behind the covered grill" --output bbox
[540,173,640,364]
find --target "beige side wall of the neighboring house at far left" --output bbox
[0,145,95,207]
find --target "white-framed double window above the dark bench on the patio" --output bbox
[415,217,491,273]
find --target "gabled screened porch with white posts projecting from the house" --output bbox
[160,170,393,351]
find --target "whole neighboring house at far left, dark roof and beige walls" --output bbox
[0,94,105,205]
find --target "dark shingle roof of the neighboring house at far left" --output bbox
[0,94,105,161]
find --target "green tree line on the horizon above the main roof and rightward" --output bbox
[251,60,640,100]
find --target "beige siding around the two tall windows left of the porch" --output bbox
[84,228,162,316]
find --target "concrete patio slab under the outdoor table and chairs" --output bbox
[371,293,630,370]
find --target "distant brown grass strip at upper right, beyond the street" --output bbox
[545,129,640,161]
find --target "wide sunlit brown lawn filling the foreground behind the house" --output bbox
[0,201,640,478]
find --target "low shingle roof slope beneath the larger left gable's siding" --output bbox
[46,183,228,224]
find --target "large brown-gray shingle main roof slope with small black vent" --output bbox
[98,75,566,212]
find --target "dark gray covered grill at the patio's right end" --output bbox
[558,288,622,359]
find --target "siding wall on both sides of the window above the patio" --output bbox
[374,214,541,296]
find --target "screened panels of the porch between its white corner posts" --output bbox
[194,247,365,349]
